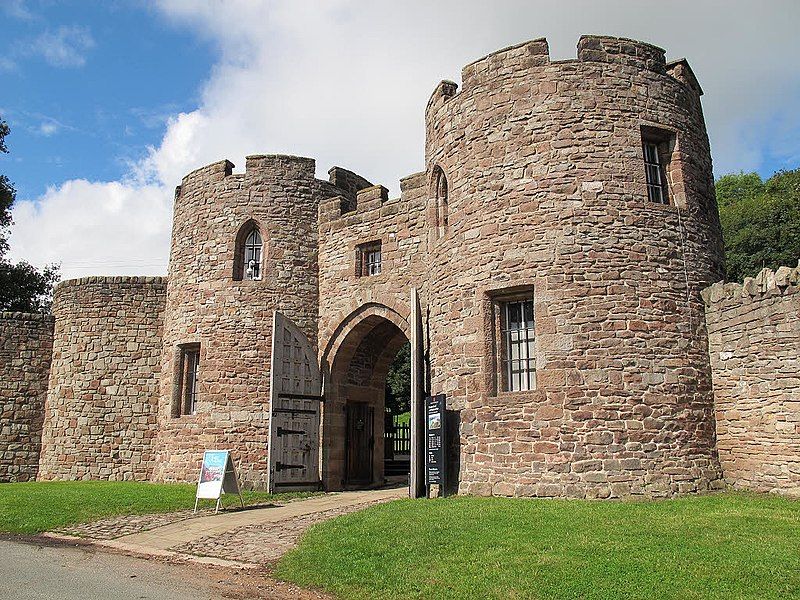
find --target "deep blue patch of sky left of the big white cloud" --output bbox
[0,0,215,199]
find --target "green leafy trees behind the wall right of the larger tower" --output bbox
[716,169,800,281]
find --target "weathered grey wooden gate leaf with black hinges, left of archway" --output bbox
[268,311,323,492]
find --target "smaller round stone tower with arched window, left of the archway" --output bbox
[155,155,333,486]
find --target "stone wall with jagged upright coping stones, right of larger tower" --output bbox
[703,267,800,496]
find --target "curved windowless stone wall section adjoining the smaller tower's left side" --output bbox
[39,277,167,480]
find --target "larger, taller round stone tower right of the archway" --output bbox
[426,37,723,497]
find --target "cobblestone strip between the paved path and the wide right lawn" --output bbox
[170,498,393,563]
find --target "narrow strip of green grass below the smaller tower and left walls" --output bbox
[0,481,318,534]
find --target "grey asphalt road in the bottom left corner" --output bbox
[0,540,224,600]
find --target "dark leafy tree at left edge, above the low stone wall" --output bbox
[0,119,59,312]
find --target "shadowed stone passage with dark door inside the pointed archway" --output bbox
[322,315,410,490]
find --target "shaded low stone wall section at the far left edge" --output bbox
[0,312,53,482]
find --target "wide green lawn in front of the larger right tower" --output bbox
[276,493,800,599]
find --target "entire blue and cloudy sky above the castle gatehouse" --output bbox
[0,0,800,277]
